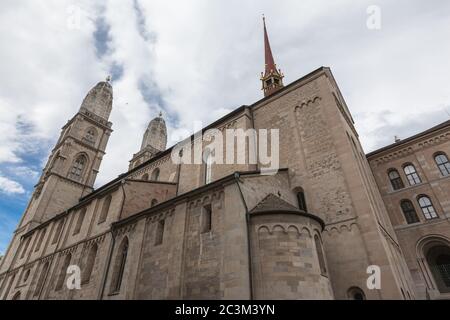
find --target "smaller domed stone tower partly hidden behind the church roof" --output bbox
[130,112,167,169]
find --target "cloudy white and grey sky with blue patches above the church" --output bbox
[0,0,450,254]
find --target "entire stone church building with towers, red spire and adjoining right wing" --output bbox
[0,20,450,300]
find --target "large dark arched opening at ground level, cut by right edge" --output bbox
[426,244,450,293]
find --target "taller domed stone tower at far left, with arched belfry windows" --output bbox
[19,78,113,229]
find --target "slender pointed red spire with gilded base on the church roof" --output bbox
[261,16,284,97]
